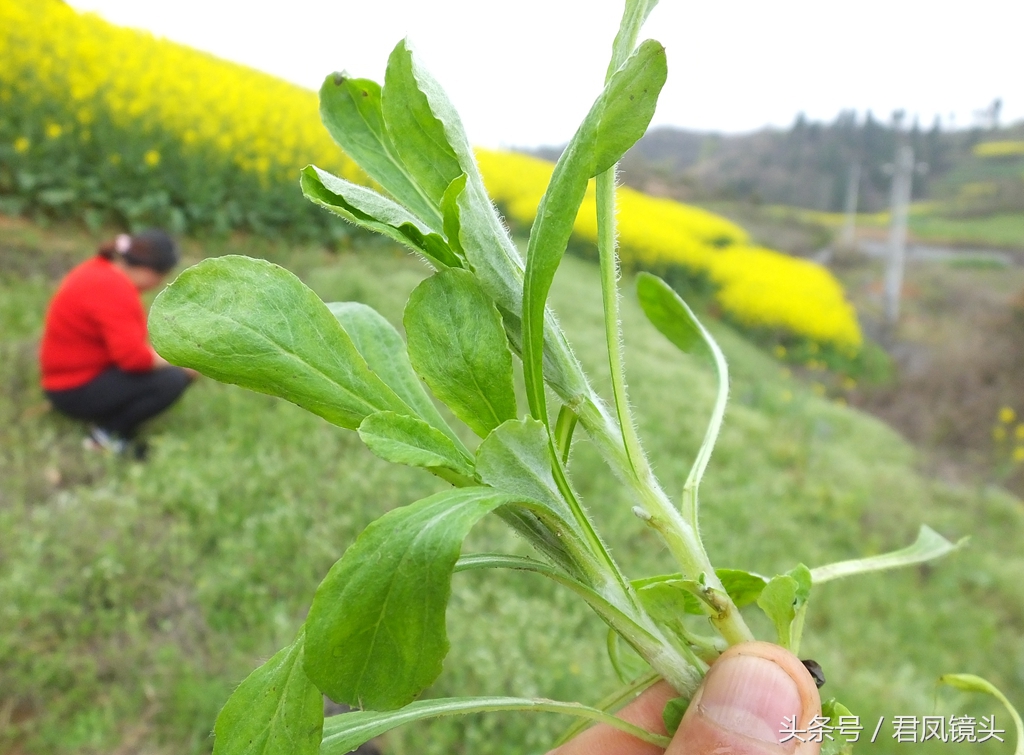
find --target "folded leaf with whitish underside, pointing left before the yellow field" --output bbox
[299,165,463,269]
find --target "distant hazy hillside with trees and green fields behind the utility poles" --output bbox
[623,119,1024,254]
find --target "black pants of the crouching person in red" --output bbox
[46,367,188,439]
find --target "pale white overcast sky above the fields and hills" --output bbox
[70,0,1024,146]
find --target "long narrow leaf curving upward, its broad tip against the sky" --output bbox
[522,41,667,422]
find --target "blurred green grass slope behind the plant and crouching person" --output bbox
[0,219,1024,755]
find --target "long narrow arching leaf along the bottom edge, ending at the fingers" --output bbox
[321,698,669,755]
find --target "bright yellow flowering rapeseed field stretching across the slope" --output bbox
[0,0,861,351]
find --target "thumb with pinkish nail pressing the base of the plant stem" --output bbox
[666,642,821,755]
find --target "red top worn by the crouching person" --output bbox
[39,256,154,390]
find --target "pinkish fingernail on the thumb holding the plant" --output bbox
[699,656,801,744]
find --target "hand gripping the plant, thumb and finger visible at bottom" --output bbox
[548,642,821,755]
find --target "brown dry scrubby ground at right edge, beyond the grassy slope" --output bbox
[831,247,1024,494]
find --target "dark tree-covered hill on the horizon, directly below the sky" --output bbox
[623,113,1024,215]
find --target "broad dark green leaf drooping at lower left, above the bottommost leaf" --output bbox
[305,488,515,710]
